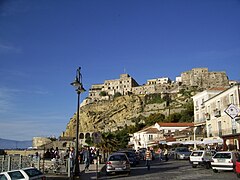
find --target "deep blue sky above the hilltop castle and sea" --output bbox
[0,0,240,140]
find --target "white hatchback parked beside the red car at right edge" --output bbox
[211,151,239,173]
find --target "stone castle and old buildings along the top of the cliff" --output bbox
[83,68,230,104]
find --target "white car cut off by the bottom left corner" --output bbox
[0,167,46,180]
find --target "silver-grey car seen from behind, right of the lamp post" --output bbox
[106,153,131,175]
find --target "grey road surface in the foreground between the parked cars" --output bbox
[83,159,238,180]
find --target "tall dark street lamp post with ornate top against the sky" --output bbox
[71,67,86,176]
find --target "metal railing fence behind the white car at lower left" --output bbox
[0,155,69,174]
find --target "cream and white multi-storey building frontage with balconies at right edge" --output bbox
[193,85,240,150]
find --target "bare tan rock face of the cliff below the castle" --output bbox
[63,95,186,137]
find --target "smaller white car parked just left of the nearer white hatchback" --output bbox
[189,150,212,169]
